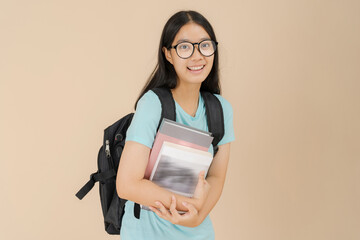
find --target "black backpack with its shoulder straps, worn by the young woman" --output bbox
[76,88,224,234]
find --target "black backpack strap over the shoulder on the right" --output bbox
[201,91,225,153]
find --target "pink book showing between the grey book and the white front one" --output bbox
[144,132,208,179]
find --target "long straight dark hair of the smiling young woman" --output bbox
[135,11,221,109]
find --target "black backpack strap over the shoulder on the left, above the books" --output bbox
[151,88,176,130]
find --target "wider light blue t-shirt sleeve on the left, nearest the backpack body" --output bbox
[126,91,161,148]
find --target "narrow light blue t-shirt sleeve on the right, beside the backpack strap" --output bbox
[215,94,235,146]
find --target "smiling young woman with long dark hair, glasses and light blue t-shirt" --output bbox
[116,11,234,240]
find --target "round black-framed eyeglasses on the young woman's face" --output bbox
[169,39,218,59]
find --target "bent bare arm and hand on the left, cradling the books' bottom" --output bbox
[116,141,207,211]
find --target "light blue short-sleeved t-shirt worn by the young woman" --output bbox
[120,91,235,240]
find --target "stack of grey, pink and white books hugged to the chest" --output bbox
[142,118,213,209]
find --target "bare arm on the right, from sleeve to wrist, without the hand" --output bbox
[198,143,230,224]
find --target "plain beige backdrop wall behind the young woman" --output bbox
[0,0,360,240]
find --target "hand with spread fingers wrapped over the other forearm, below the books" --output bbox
[149,195,201,227]
